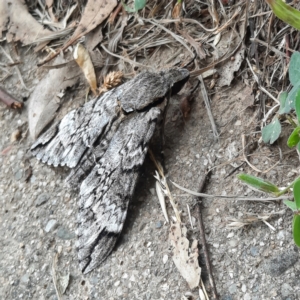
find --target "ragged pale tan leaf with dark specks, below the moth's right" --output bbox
[169,222,201,289]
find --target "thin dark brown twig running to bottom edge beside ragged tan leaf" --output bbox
[196,174,219,300]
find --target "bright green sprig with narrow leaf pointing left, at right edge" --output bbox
[237,174,300,247]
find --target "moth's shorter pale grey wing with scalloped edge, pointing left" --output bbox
[31,90,118,168]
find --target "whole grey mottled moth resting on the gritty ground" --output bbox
[31,68,189,274]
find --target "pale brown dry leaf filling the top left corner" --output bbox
[0,0,52,45]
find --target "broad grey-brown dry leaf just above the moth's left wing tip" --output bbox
[28,56,80,139]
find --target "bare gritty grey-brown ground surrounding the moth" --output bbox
[0,41,300,300]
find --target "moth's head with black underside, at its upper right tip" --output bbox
[162,68,190,95]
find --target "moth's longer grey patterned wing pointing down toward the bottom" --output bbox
[77,108,160,274]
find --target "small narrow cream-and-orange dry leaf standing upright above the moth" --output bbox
[73,44,98,96]
